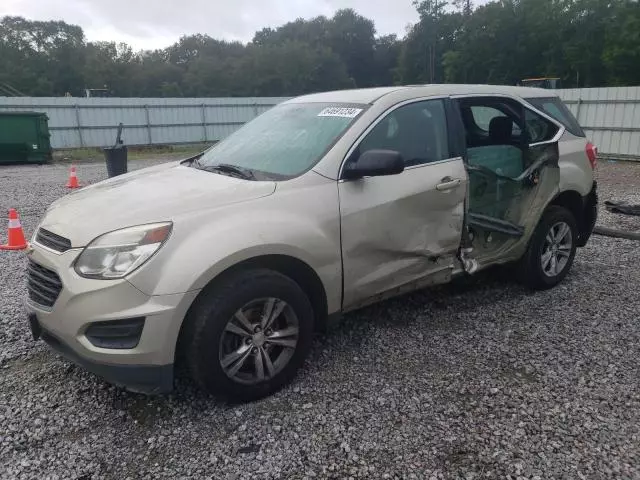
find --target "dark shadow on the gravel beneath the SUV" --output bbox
[76,269,534,414]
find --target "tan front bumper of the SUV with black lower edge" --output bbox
[26,244,198,393]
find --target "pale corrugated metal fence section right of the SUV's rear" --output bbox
[557,87,640,160]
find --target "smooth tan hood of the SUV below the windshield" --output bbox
[40,162,276,248]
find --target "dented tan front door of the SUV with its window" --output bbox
[338,99,467,309]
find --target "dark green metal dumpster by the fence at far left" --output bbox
[0,111,51,164]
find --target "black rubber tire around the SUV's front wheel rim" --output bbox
[182,269,314,401]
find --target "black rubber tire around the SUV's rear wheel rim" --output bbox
[518,205,578,290]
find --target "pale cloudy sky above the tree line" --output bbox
[0,0,418,49]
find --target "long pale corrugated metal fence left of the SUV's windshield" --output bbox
[0,97,286,148]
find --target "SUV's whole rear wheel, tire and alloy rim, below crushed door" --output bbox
[520,206,578,290]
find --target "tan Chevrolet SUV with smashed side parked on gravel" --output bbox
[27,85,597,399]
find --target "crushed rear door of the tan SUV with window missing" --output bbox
[457,96,564,264]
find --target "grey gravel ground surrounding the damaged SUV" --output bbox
[0,162,640,479]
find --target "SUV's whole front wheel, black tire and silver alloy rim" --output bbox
[185,270,314,400]
